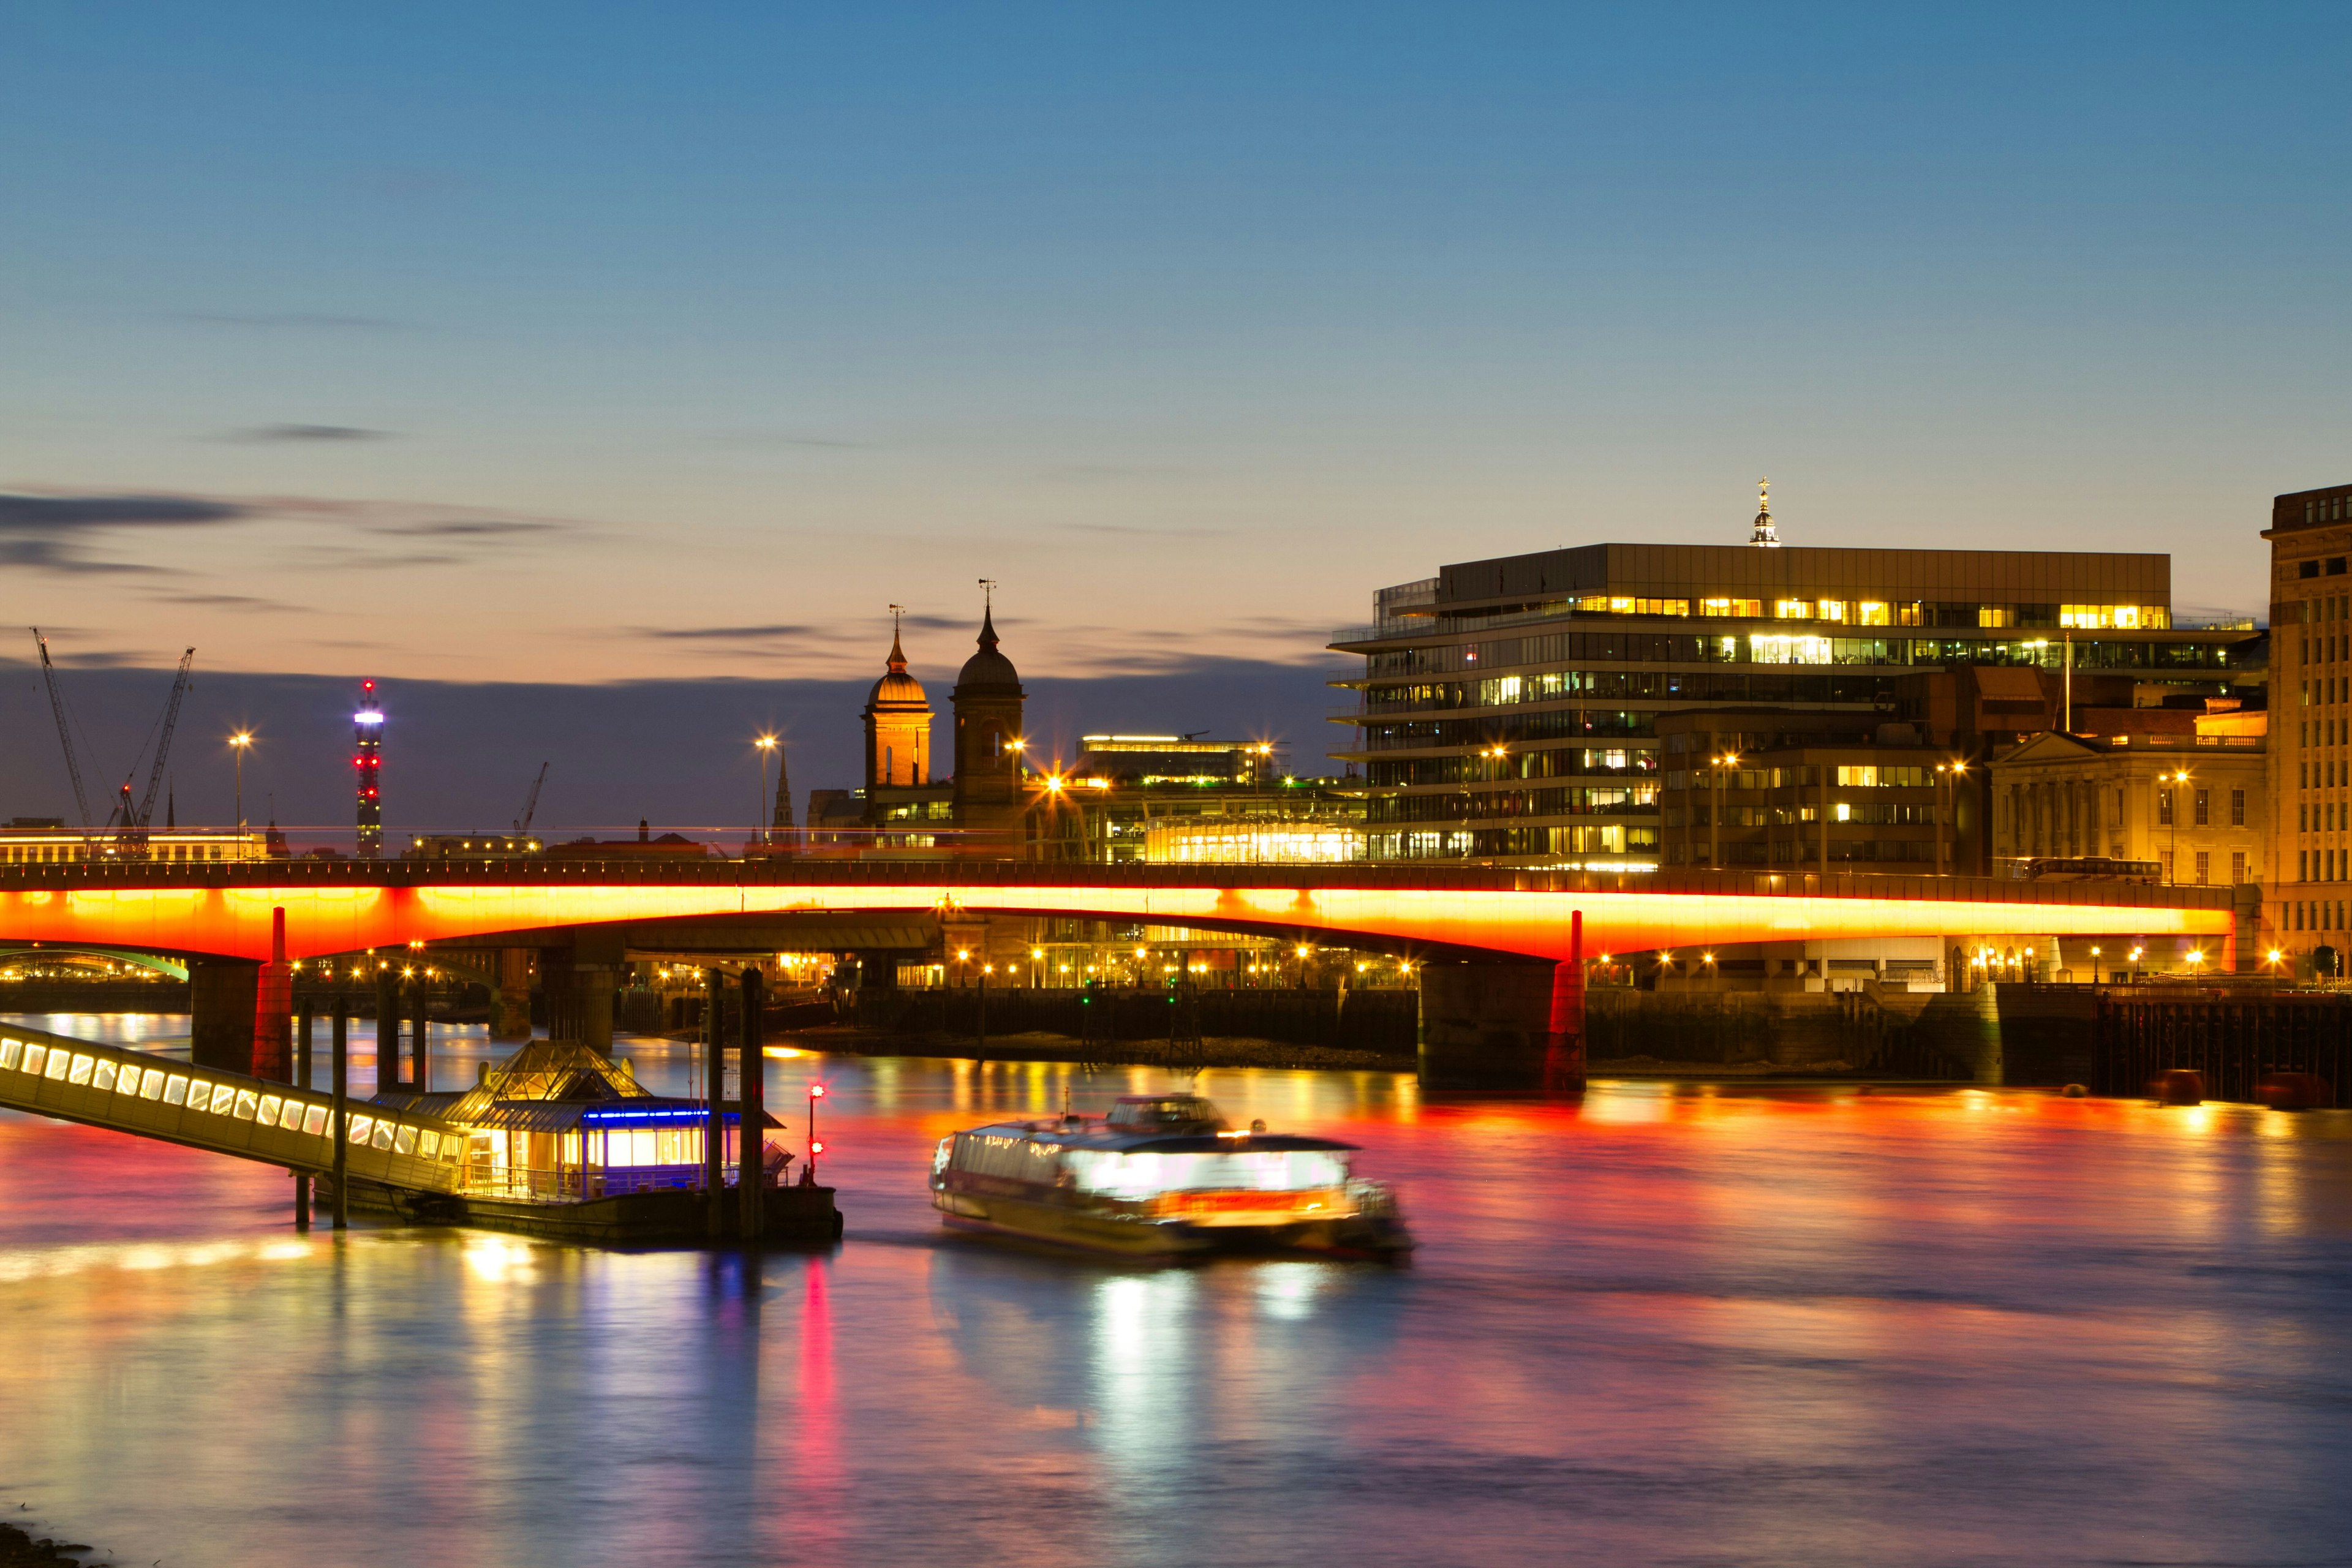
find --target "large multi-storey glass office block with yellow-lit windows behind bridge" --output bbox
[1331,513,2260,872]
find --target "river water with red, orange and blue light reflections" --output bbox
[0,1018,2352,1568]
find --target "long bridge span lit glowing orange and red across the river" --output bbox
[0,858,2234,1090]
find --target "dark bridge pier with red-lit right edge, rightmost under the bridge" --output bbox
[1420,964,1585,1093]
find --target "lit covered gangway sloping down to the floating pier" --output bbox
[0,1025,466,1192]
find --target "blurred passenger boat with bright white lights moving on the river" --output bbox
[932,1096,1414,1257]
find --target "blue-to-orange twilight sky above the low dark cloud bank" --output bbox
[0,2,2352,820]
